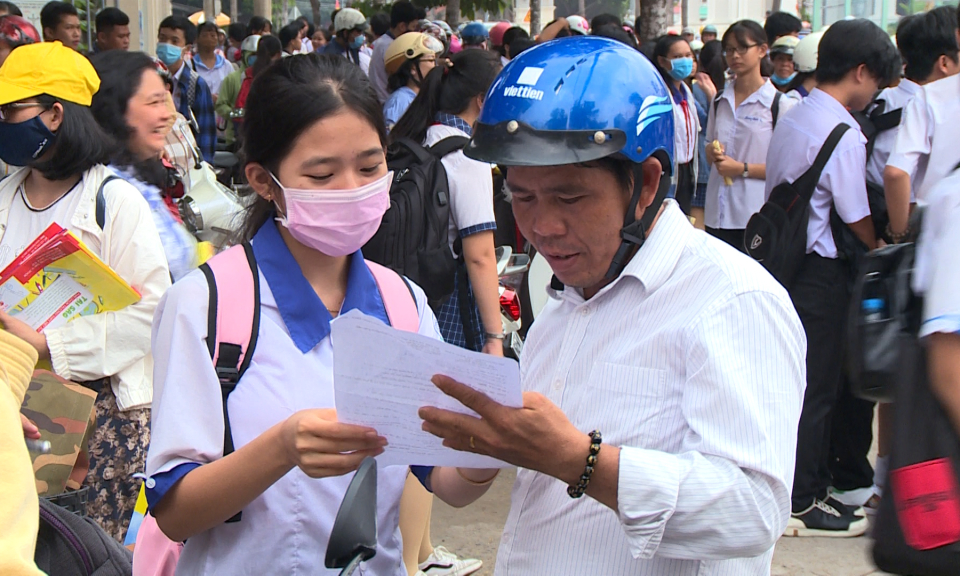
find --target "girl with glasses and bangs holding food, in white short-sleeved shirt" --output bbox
[705,20,797,251]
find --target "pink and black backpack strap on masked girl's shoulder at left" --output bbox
[200,243,260,522]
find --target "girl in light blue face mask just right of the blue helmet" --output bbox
[653,35,700,215]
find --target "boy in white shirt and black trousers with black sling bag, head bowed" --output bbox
[766,20,899,536]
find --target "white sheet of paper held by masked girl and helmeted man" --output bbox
[331,310,523,468]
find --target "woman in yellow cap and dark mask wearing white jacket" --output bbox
[0,42,170,540]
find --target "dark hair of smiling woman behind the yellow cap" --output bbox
[90,50,167,188]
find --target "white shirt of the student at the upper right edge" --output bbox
[887,75,960,202]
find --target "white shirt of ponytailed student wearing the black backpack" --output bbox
[423,124,497,256]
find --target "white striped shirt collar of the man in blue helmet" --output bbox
[547,200,693,299]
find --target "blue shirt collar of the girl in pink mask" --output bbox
[252,216,390,354]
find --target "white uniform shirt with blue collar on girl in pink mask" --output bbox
[146,218,440,576]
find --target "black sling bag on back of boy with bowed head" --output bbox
[744,124,850,288]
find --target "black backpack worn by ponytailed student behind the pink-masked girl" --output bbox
[363,136,469,310]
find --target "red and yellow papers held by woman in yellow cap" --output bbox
[0,223,140,332]
